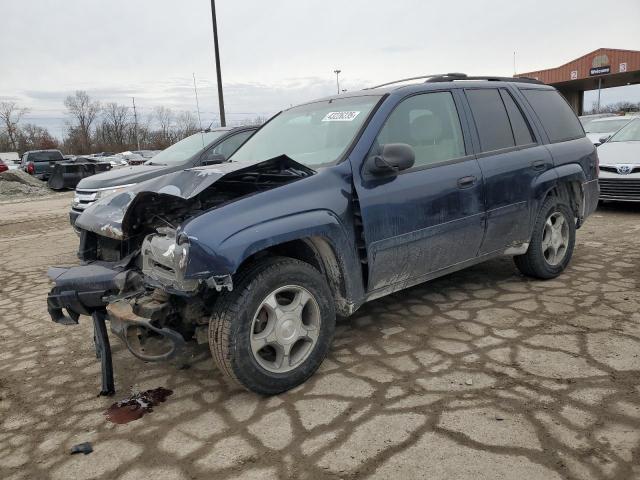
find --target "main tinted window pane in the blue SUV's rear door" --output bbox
[465,88,515,152]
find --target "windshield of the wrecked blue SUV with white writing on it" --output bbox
[230,95,380,168]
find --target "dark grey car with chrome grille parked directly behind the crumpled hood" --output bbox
[69,126,257,225]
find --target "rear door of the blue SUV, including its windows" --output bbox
[465,88,553,255]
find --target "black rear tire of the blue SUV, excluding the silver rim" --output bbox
[513,197,576,280]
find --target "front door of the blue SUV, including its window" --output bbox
[356,91,484,293]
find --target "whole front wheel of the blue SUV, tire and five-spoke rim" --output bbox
[209,257,335,395]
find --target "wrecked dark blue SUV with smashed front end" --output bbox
[48,74,598,395]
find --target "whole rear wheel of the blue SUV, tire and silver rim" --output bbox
[514,197,576,280]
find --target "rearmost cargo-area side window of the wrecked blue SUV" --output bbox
[522,90,584,143]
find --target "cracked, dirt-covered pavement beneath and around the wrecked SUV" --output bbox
[0,194,640,480]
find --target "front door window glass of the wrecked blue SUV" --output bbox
[376,92,466,168]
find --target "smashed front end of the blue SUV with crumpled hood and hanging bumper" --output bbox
[48,156,315,394]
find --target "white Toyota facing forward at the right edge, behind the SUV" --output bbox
[598,118,640,202]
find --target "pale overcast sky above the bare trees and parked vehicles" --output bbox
[0,0,640,136]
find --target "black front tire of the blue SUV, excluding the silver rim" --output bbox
[209,257,336,395]
